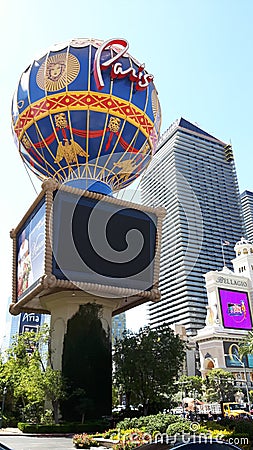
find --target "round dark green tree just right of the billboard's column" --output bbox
[113,325,185,414]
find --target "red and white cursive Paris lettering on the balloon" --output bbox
[94,39,154,91]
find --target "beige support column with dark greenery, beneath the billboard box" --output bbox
[41,291,121,421]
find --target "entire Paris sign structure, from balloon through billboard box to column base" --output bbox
[10,39,164,420]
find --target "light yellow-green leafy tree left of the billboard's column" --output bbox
[0,326,64,423]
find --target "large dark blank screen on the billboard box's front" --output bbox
[52,190,157,291]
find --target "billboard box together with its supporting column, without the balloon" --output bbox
[10,179,165,421]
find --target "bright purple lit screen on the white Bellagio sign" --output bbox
[219,289,252,330]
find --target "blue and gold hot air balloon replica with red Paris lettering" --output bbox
[12,39,161,194]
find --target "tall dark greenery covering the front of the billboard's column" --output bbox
[61,303,112,421]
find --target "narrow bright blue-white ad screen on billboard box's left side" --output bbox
[16,200,45,300]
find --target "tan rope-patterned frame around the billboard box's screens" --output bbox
[9,179,166,315]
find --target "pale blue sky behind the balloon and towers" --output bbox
[0,0,253,330]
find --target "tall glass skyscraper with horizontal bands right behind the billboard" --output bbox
[141,118,243,335]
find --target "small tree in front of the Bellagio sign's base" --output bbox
[204,369,235,401]
